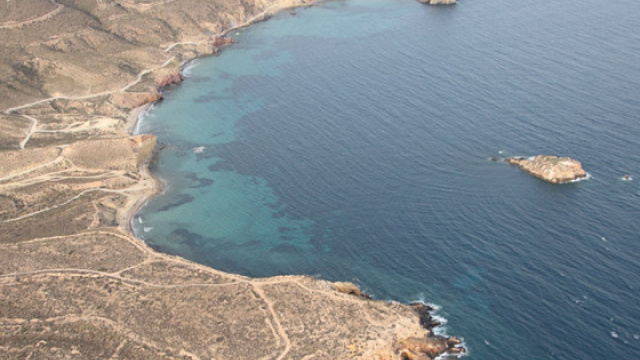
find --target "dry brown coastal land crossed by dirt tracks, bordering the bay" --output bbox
[0,0,463,359]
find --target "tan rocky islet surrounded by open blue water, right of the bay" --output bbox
[504,155,587,184]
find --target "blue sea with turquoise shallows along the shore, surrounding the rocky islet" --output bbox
[134,0,640,360]
